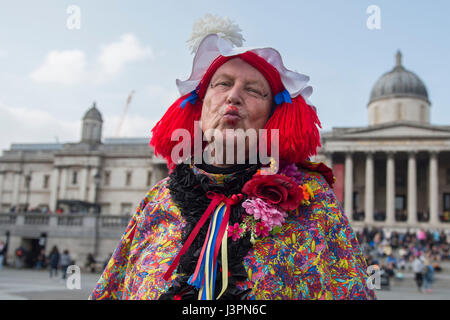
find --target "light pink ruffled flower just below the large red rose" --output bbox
[242,198,287,231]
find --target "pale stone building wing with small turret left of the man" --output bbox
[0,103,167,215]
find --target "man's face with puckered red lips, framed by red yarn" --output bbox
[201,58,272,138]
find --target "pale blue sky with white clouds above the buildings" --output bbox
[0,0,450,154]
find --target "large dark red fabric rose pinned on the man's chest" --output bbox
[242,174,303,211]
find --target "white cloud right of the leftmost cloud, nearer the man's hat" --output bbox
[98,33,153,77]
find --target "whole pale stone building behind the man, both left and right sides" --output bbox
[0,52,450,227]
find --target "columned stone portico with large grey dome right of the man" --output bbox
[317,52,450,228]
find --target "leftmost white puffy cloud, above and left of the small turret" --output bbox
[30,50,87,85]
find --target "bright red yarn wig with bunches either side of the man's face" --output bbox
[150,51,321,170]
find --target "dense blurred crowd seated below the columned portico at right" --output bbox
[357,228,450,293]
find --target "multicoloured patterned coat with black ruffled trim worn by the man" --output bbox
[89,162,376,300]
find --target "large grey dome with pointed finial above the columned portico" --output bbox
[369,51,430,104]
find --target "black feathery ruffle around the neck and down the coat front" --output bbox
[160,164,260,300]
